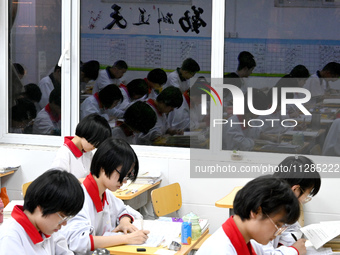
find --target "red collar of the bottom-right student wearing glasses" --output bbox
[222,216,256,255]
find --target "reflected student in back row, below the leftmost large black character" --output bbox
[92,60,128,94]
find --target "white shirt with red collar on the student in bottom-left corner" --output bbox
[0,205,73,255]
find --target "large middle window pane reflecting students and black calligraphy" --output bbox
[80,0,211,148]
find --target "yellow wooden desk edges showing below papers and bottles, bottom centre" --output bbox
[106,229,209,255]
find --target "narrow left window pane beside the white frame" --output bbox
[8,0,61,135]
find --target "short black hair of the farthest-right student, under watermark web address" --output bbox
[273,156,321,196]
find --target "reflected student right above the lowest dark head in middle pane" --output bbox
[111,79,148,118]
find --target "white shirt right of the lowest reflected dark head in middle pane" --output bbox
[137,99,169,145]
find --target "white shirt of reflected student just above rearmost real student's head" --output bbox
[80,93,111,121]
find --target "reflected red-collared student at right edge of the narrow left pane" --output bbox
[33,88,61,135]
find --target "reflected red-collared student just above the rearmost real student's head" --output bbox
[80,84,123,121]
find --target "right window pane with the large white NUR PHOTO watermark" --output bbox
[220,0,340,156]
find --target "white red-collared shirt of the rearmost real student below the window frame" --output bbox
[51,136,93,178]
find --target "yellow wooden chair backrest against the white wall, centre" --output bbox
[151,182,182,217]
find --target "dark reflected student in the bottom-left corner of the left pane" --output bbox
[9,98,37,134]
